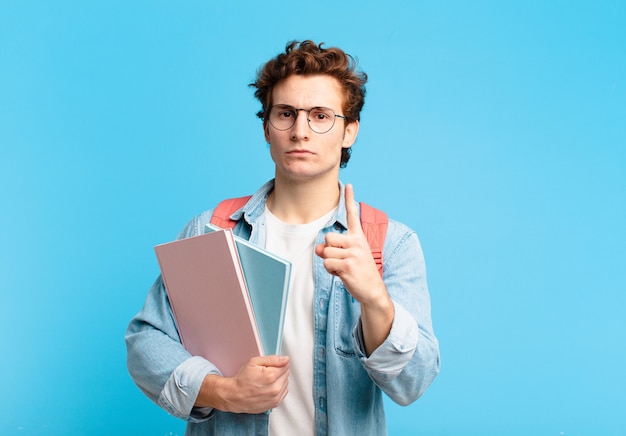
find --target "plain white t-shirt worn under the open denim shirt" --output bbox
[265,207,336,436]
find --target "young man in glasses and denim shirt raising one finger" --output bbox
[126,41,439,435]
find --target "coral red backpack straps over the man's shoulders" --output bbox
[211,195,389,276]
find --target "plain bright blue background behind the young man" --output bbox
[0,0,626,436]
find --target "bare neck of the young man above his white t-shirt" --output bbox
[267,174,340,224]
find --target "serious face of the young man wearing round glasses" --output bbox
[264,75,359,182]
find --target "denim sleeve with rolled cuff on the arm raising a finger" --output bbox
[353,225,439,405]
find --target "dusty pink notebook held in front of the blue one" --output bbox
[154,230,263,377]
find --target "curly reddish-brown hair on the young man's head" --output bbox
[250,40,367,168]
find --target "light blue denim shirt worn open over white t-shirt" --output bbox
[126,181,439,435]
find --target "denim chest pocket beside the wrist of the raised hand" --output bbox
[332,278,361,357]
